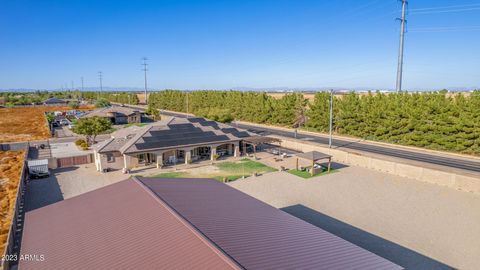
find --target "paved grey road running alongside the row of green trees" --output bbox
[162,112,480,173]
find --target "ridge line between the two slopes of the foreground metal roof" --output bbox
[131,176,245,269]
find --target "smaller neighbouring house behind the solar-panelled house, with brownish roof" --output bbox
[83,106,142,125]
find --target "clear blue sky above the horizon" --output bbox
[0,0,480,89]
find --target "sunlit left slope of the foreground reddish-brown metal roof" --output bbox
[19,179,238,270]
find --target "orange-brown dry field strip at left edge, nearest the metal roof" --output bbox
[0,151,24,254]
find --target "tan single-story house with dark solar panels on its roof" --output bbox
[93,117,267,171]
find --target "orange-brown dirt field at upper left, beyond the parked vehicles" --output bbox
[0,106,88,143]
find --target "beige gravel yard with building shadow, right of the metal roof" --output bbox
[229,167,480,269]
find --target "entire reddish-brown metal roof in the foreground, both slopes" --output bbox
[19,177,402,270]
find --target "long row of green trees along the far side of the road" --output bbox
[149,90,480,155]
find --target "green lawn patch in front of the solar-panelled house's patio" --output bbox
[152,159,276,182]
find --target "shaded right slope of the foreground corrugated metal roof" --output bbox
[140,178,401,270]
